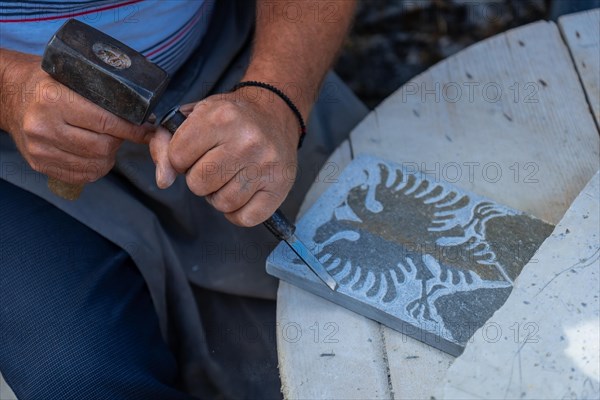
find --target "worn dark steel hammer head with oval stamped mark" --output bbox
[42,19,169,125]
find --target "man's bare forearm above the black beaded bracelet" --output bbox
[243,0,356,119]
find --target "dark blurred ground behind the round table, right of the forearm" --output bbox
[335,0,558,108]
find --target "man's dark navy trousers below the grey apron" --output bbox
[0,180,279,400]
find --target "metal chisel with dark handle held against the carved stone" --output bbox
[160,107,337,290]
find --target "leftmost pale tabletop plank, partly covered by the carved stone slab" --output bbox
[277,141,391,399]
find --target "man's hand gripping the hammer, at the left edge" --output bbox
[0,49,153,184]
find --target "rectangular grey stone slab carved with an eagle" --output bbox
[267,156,553,355]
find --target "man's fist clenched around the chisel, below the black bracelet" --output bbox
[150,88,300,226]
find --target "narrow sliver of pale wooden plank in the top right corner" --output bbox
[558,8,600,125]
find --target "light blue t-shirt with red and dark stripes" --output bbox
[0,0,215,73]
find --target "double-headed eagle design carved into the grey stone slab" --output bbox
[313,164,544,322]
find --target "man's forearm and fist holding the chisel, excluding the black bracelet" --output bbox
[150,0,356,226]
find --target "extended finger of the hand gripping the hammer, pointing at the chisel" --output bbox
[63,96,155,144]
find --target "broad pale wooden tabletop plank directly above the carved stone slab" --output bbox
[351,22,599,224]
